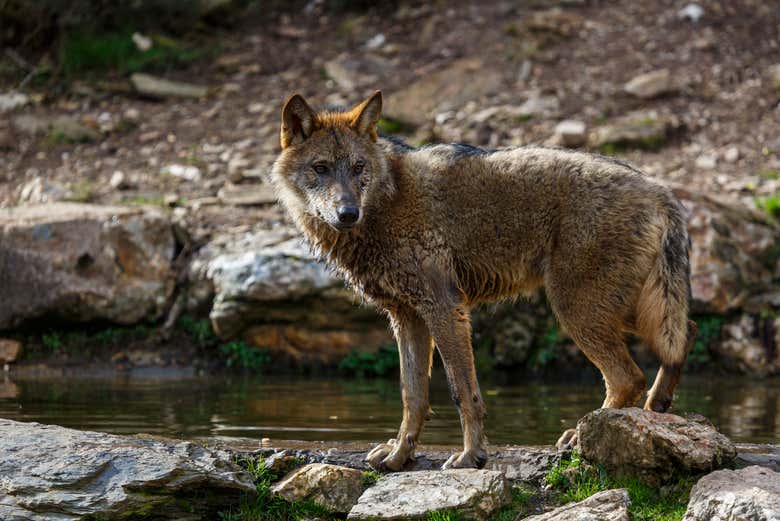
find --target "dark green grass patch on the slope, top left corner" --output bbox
[59,29,204,78]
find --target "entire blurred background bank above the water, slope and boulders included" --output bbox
[0,0,780,376]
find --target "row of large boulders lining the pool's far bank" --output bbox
[0,179,780,377]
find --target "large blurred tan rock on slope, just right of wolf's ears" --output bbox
[383,58,503,126]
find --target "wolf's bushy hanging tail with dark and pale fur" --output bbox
[636,194,696,366]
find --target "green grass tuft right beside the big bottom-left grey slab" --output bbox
[219,457,338,521]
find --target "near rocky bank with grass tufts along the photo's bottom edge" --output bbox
[0,409,780,521]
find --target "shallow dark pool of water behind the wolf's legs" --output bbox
[0,373,780,445]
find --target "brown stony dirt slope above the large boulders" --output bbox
[0,0,780,244]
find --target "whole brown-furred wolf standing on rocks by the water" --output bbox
[271,92,695,470]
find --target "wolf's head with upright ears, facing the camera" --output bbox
[271,91,388,231]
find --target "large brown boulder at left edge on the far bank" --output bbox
[0,203,174,330]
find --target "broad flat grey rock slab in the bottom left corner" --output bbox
[0,420,256,521]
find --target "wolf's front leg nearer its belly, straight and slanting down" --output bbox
[426,302,487,469]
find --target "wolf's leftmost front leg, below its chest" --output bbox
[366,308,433,471]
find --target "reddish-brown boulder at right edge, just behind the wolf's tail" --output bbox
[674,187,780,315]
